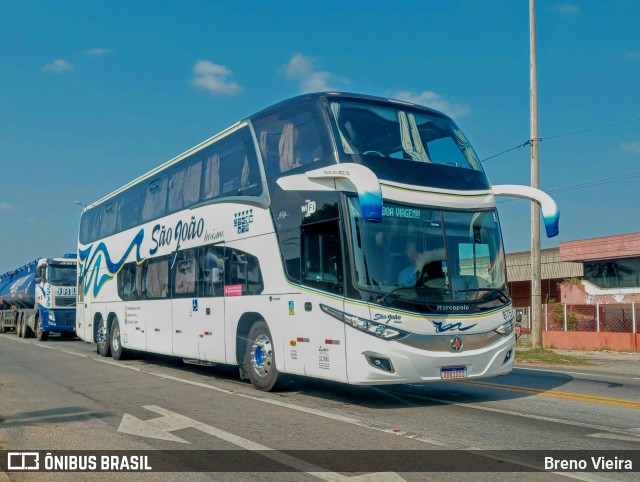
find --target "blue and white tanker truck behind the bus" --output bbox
[0,254,77,341]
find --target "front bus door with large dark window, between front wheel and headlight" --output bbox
[295,220,347,381]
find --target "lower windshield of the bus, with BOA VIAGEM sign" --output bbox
[348,197,507,304]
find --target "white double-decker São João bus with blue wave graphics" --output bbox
[77,93,558,390]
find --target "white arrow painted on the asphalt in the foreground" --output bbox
[118,405,404,482]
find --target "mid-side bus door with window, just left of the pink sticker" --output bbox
[198,244,225,363]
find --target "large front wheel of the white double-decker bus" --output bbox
[244,320,282,392]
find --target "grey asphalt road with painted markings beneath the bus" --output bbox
[0,334,640,482]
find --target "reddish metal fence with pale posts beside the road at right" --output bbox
[542,303,640,333]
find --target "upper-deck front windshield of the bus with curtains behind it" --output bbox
[329,100,482,171]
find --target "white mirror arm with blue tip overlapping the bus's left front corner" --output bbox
[277,163,382,221]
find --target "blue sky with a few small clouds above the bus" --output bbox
[0,0,640,273]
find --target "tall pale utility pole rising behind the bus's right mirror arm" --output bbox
[529,0,542,348]
